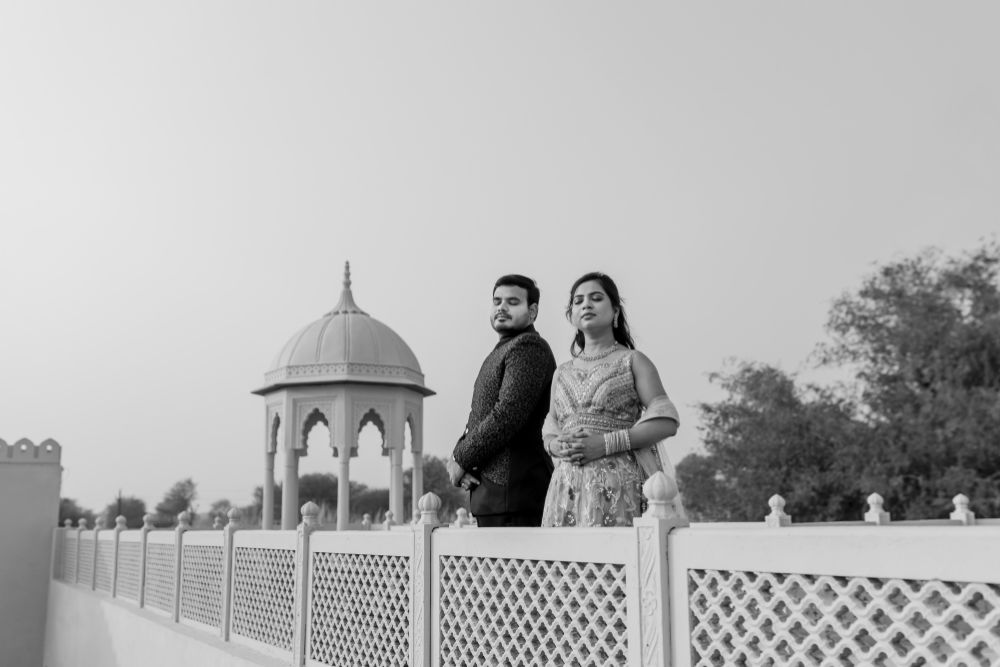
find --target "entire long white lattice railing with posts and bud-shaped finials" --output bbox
[53,478,1000,667]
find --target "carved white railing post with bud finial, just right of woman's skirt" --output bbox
[632,471,688,667]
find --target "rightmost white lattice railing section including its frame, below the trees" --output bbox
[669,525,1000,667]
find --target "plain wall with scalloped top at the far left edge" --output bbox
[0,439,62,667]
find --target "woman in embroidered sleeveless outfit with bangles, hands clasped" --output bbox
[542,273,683,526]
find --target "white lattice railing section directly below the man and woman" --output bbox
[432,528,641,666]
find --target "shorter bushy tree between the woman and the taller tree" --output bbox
[677,363,864,521]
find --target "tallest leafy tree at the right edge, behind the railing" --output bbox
[822,243,1000,518]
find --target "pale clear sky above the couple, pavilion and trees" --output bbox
[0,0,1000,511]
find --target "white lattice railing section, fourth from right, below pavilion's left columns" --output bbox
[230,530,296,659]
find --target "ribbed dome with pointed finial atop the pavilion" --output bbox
[253,263,434,396]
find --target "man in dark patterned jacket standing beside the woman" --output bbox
[448,275,556,527]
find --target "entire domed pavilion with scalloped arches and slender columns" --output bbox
[253,262,434,530]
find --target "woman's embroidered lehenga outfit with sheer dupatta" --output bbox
[542,351,682,526]
